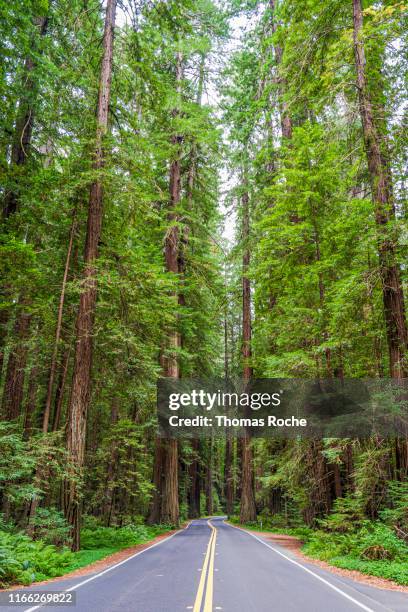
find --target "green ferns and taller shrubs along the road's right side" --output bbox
[230,482,408,585]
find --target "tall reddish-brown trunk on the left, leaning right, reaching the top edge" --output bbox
[65,0,116,551]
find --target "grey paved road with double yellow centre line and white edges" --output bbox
[0,518,408,612]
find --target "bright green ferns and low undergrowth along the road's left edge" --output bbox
[0,525,171,588]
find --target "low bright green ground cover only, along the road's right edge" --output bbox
[229,517,408,585]
